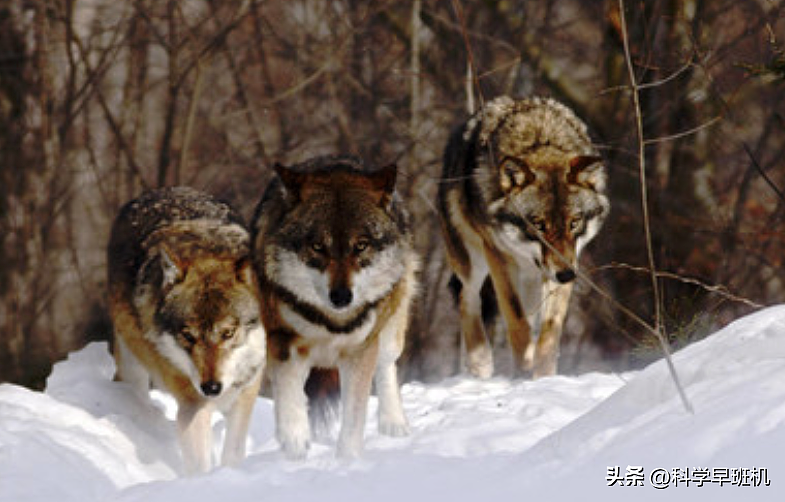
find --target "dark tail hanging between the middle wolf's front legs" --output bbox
[305,368,341,439]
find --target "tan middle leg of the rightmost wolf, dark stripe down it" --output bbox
[485,246,531,373]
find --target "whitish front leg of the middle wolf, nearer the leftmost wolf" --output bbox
[270,358,311,460]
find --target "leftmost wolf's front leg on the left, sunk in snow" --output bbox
[177,402,213,475]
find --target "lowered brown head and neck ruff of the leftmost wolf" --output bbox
[135,222,265,398]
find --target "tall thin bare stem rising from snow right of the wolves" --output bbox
[619,0,694,413]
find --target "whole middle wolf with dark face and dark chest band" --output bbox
[251,156,419,459]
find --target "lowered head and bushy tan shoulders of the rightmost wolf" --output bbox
[475,98,610,283]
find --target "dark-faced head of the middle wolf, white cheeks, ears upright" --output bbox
[263,159,408,320]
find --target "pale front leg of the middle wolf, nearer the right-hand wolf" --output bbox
[338,334,379,458]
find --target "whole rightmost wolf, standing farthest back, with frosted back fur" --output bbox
[438,96,610,378]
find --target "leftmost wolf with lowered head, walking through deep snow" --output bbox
[107,187,266,474]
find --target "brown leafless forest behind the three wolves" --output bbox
[0,0,785,387]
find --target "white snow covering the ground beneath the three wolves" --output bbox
[0,306,785,502]
